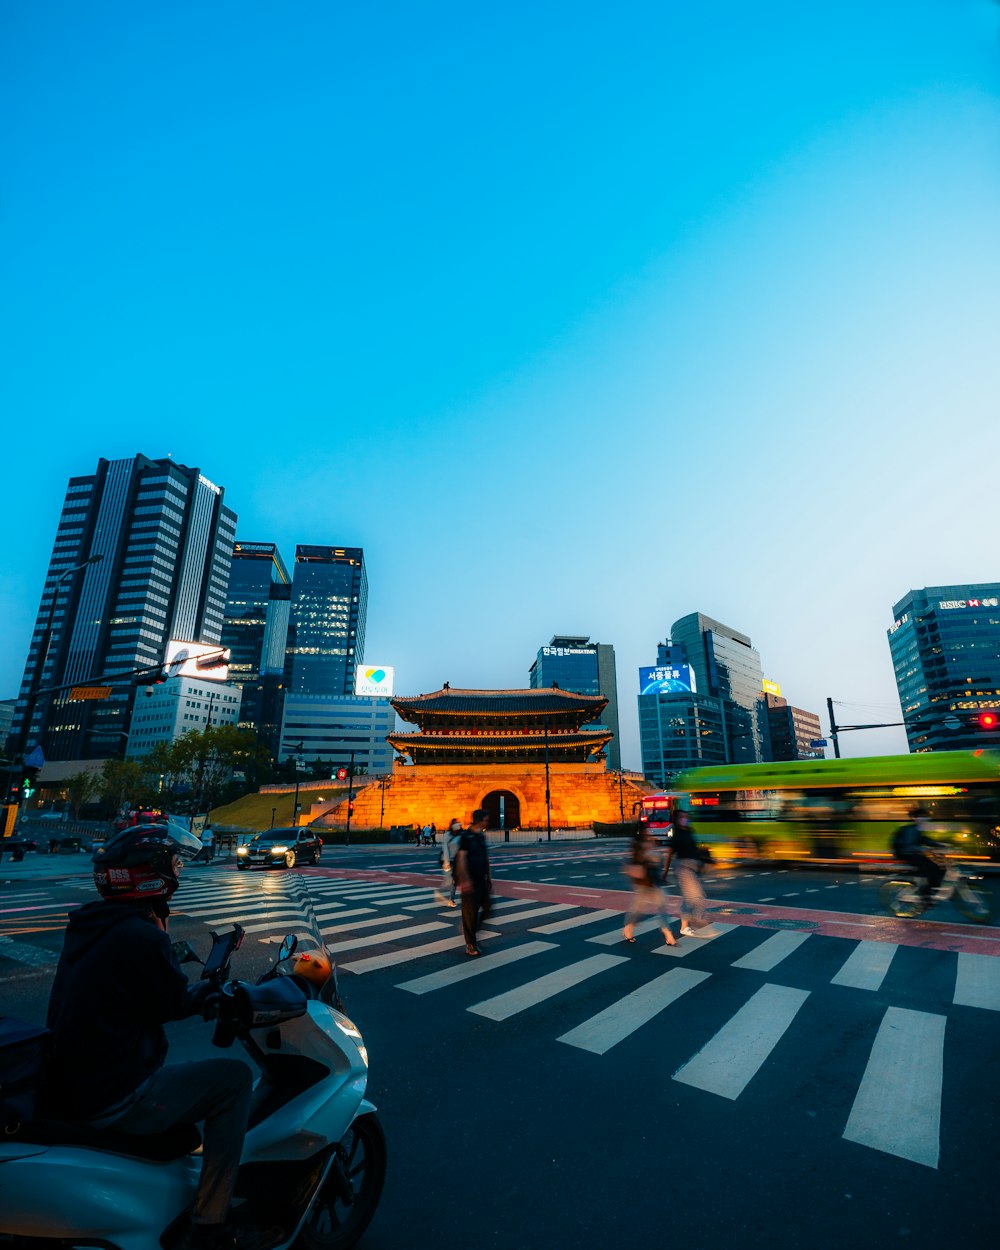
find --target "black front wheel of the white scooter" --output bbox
[294,1111,388,1250]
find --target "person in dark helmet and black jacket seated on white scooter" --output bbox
[45,825,254,1250]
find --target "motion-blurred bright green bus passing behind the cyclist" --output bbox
[671,751,1000,864]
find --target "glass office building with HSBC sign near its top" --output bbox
[888,581,1000,751]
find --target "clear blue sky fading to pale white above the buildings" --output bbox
[0,0,1000,766]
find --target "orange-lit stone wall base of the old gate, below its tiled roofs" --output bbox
[310,764,650,829]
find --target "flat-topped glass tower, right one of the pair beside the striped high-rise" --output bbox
[285,546,368,696]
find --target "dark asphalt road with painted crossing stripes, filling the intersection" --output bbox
[0,844,1000,1250]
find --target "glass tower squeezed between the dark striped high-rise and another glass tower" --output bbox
[223,543,291,756]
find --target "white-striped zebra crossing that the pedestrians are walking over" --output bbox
[178,874,1000,1168]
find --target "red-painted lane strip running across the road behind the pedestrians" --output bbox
[302,868,1000,958]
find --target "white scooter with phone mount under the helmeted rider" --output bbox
[0,925,386,1250]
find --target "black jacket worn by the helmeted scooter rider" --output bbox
[45,900,188,1120]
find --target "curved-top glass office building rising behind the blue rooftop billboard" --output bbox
[670,613,766,764]
